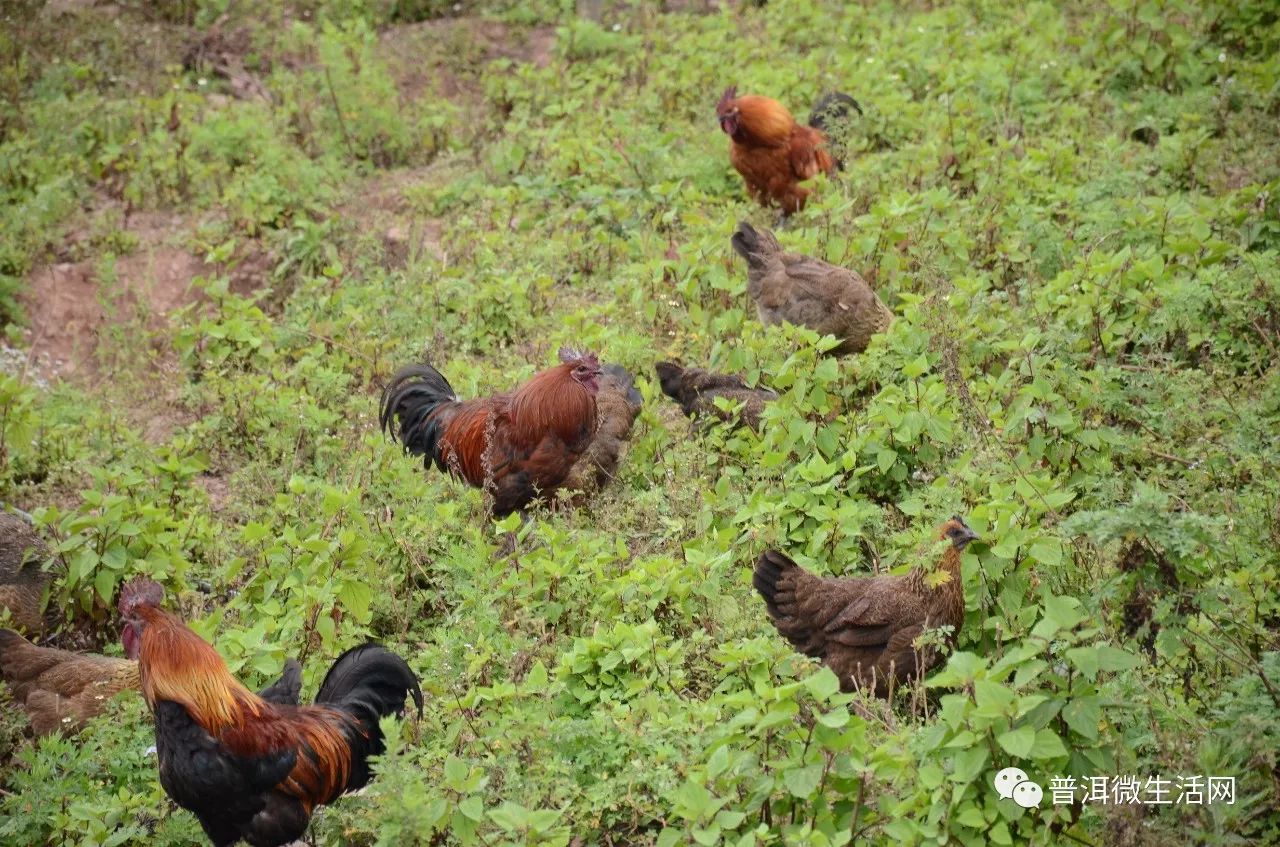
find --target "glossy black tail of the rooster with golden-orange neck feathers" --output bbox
[316,644,422,791]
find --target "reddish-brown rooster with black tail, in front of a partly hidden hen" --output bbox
[380,348,602,517]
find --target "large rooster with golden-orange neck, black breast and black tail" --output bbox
[119,578,422,847]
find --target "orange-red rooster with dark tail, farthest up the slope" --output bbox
[716,86,861,215]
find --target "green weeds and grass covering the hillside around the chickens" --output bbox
[0,0,1280,846]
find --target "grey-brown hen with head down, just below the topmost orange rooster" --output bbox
[730,221,893,356]
